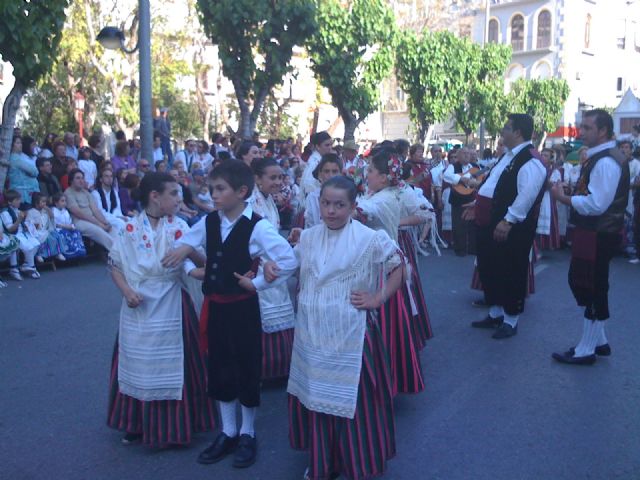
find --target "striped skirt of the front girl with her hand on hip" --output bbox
[289,318,395,480]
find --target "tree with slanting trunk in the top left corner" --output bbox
[0,0,68,191]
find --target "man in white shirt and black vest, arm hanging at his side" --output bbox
[471,114,547,339]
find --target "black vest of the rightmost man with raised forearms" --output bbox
[570,148,630,233]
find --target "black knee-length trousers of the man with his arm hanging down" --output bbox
[476,225,535,315]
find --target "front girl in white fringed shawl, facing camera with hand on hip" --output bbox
[287,177,404,480]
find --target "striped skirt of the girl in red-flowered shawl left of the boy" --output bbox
[107,290,215,447]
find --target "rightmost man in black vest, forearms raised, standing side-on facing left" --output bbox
[551,109,629,365]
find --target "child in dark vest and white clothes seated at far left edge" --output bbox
[0,190,40,280]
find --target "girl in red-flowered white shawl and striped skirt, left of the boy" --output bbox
[107,172,214,447]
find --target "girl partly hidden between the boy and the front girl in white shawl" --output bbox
[249,158,295,380]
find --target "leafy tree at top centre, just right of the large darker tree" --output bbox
[307,0,396,140]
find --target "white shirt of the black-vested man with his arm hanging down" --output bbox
[478,142,547,223]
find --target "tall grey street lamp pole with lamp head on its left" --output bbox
[96,0,153,160]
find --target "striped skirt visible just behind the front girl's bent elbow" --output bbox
[380,286,424,396]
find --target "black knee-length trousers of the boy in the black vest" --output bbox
[208,295,262,407]
